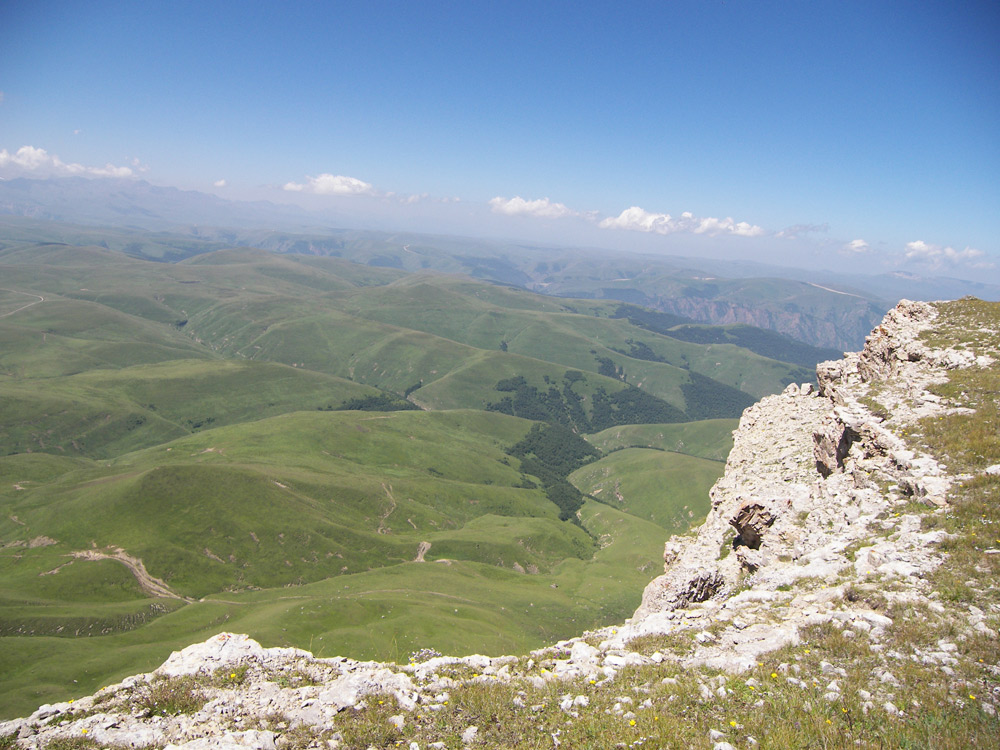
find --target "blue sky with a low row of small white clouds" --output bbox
[0,0,1000,282]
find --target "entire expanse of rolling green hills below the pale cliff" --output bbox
[0,234,820,717]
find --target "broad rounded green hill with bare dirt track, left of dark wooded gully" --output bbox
[0,412,590,597]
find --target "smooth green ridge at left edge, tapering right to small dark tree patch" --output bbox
[0,359,378,458]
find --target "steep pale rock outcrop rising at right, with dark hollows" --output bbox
[627,301,992,667]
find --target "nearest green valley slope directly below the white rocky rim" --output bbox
[0,501,663,716]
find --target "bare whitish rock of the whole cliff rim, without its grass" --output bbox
[0,301,1000,750]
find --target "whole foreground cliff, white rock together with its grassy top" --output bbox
[0,301,1000,750]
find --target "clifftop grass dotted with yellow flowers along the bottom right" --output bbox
[292,627,998,749]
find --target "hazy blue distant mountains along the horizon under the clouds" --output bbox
[0,177,1000,351]
